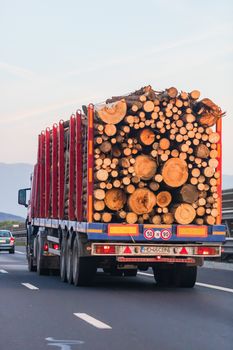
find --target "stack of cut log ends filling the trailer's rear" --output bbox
[93,86,223,225]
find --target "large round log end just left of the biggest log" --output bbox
[134,155,157,180]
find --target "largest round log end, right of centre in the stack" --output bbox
[162,158,188,187]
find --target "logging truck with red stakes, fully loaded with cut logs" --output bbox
[18,86,225,288]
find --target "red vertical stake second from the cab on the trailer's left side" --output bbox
[45,128,51,218]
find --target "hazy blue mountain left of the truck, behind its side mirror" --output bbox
[0,163,33,217]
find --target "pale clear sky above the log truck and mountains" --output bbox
[0,0,233,174]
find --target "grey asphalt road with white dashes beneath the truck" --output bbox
[0,248,233,350]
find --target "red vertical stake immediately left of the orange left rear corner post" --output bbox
[76,110,83,222]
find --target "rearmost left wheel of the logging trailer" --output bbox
[72,237,97,286]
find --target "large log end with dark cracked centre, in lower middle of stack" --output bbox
[128,188,156,215]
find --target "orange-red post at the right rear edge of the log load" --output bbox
[216,118,222,225]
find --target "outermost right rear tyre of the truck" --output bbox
[175,265,197,288]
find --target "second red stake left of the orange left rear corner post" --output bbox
[68,115,75,220]
